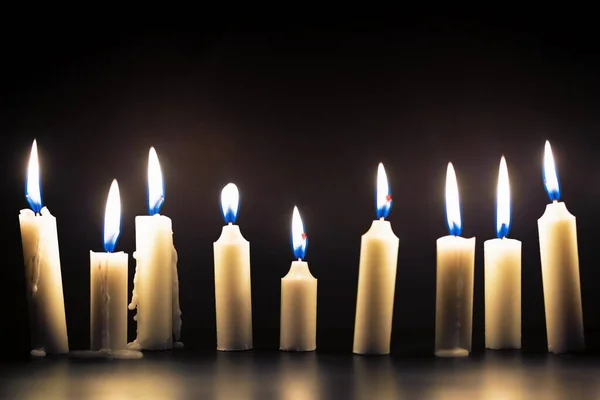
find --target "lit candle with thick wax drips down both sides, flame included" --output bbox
[129,147,181,350]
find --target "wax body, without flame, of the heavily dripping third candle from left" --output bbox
[130,214,176,350]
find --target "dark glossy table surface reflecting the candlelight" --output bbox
[0,350,600,400]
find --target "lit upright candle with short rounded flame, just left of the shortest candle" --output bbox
[213,183,252,351]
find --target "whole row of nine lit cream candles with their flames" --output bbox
[19,141,584,357]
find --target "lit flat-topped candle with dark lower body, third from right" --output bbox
[435,163,475,357]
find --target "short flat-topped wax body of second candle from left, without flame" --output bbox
[90,251,128,350]
